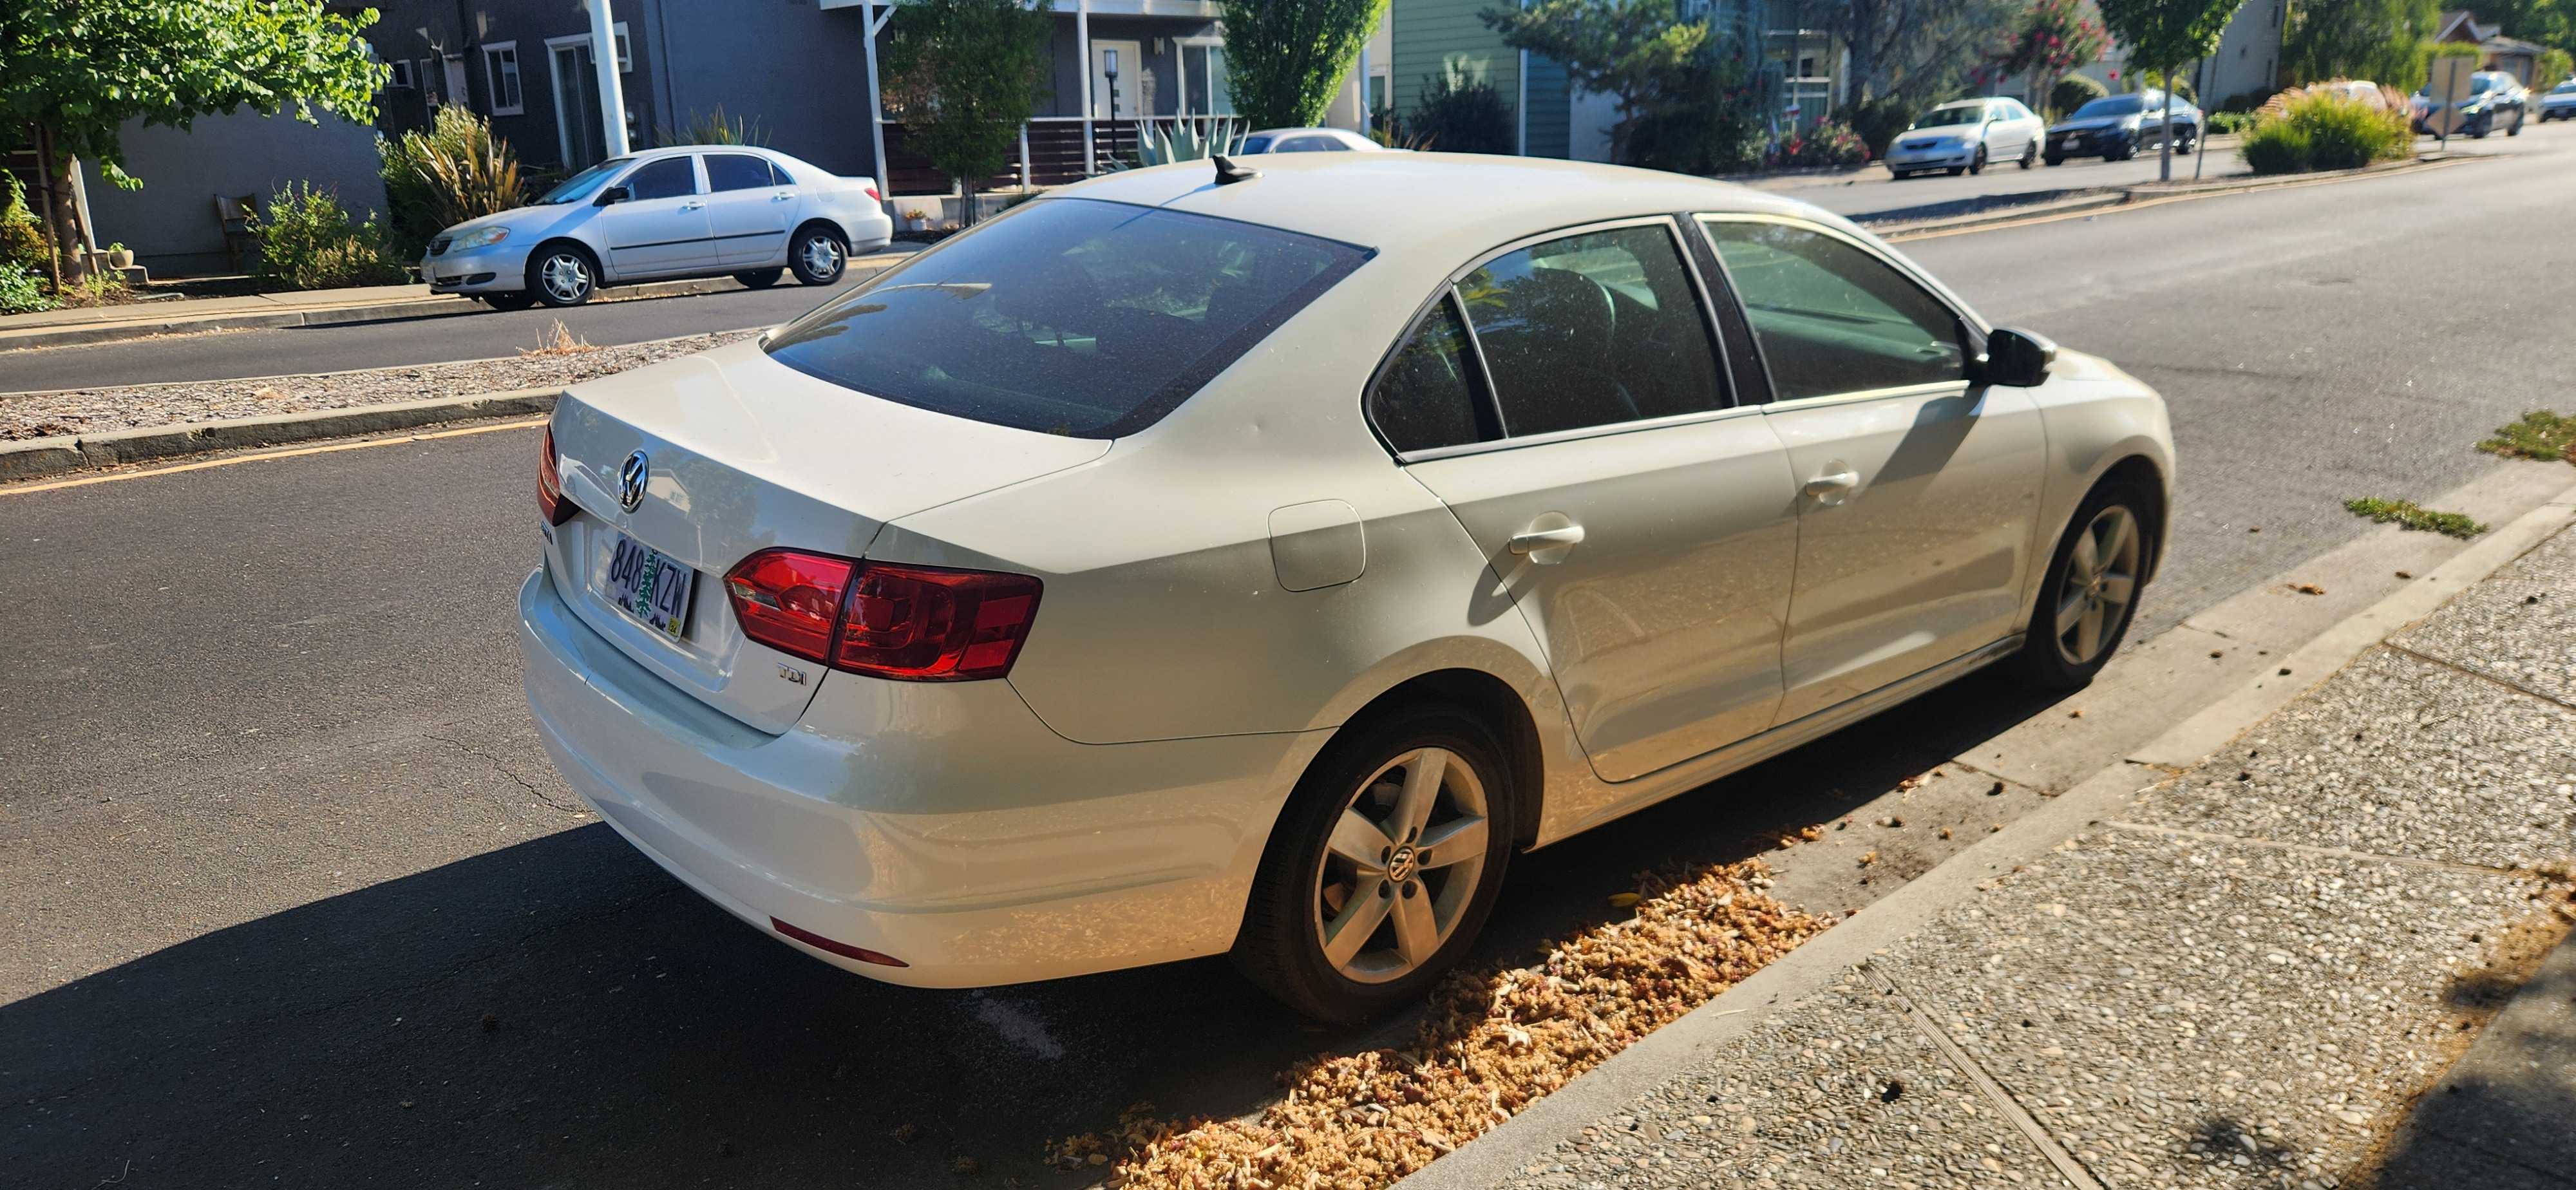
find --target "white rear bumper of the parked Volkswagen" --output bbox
[520,569,1316,987]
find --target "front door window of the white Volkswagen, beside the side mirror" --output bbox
[1705,222,1965,402]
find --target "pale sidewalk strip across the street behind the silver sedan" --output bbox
[0,242,922,350]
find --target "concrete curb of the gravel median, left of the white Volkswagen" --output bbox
[0,386,564,482]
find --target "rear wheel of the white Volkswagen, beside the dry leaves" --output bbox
[1234,703,1517,1023]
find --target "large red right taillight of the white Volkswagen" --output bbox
[724,549,1038,683]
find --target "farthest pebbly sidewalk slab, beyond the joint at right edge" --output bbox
[2396,533,2576,706]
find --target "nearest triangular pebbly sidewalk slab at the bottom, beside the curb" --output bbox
[1504,971,2056,1190]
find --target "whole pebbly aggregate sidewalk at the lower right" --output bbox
[1404,513,2576,1190]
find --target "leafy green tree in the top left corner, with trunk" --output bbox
[0,0,386,283]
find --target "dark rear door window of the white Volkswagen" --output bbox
[1458,224,1723,435]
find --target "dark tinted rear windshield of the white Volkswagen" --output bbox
[768,198,1368,438]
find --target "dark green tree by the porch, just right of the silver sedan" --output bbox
[878,0,1054,224]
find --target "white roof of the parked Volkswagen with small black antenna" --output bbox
[1041,152,1850,260]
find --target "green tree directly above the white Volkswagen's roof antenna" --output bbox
[1221,0,1388,129]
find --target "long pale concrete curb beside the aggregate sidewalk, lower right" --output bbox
[1396,469,2576,1190]
